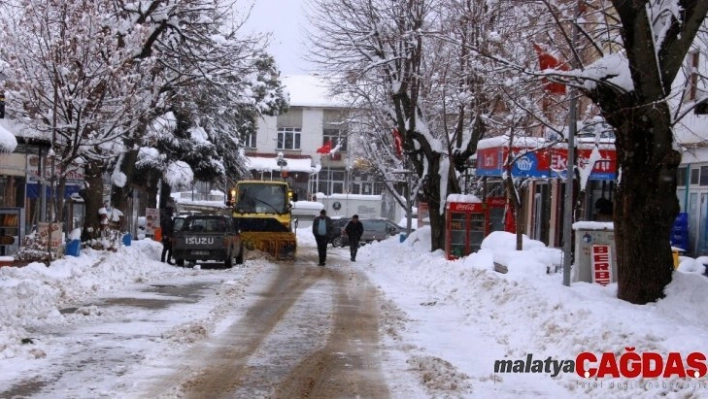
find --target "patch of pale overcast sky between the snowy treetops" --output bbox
[246,0,308,75]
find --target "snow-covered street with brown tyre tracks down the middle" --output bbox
[0,242,389,398]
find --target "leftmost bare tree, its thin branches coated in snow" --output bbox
[0,0,156,238]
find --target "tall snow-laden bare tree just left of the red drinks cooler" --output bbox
[311,0,516,250]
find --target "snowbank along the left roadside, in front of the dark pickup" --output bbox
[0,241,184,358]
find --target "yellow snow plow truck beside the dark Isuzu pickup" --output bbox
[228,180,297,260]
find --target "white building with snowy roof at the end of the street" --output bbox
[246,75,384,203]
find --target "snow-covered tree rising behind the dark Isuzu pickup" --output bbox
[112,0,285,216]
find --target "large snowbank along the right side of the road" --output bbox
[357,227,708,398]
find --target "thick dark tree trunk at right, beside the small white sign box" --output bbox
[607,103,681,304]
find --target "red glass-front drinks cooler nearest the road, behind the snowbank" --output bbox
[445,202,489,260]
